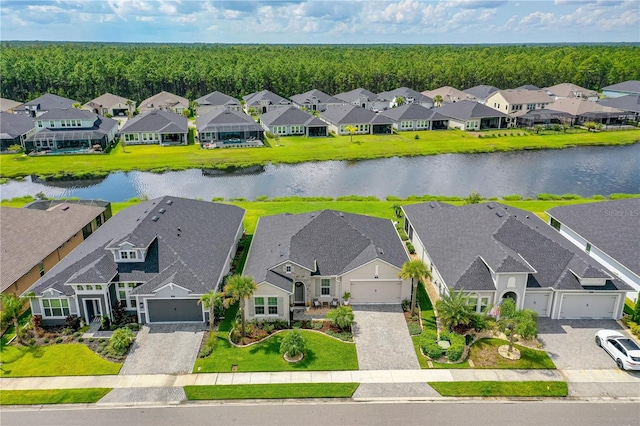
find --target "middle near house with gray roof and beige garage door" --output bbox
[244,210,411,320]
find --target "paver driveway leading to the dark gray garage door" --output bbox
[120,324,205,374]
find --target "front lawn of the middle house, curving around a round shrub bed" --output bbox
[194,330,358,373]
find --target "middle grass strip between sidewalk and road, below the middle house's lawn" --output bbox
[184,383,358,401]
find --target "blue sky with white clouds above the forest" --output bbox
[0,0,640,44]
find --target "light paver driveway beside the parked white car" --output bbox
[538,318,622,370]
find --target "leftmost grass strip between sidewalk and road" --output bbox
[0,388,111,405]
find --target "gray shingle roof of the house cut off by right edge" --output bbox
[547,198,640,276]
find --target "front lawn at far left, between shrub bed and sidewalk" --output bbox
[0,343,122,377]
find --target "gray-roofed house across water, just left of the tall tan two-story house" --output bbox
[437,100,508,130]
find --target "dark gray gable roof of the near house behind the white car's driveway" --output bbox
[403,203,629,291]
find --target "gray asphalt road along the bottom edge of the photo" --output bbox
[5,400,640,426]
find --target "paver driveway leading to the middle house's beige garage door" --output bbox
[353,305,420,370]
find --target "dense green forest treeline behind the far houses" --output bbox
[0,42,640,103]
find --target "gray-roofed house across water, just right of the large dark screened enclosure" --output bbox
[260,106,328,137]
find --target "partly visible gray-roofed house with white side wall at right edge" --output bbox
[547,198,640,300]
